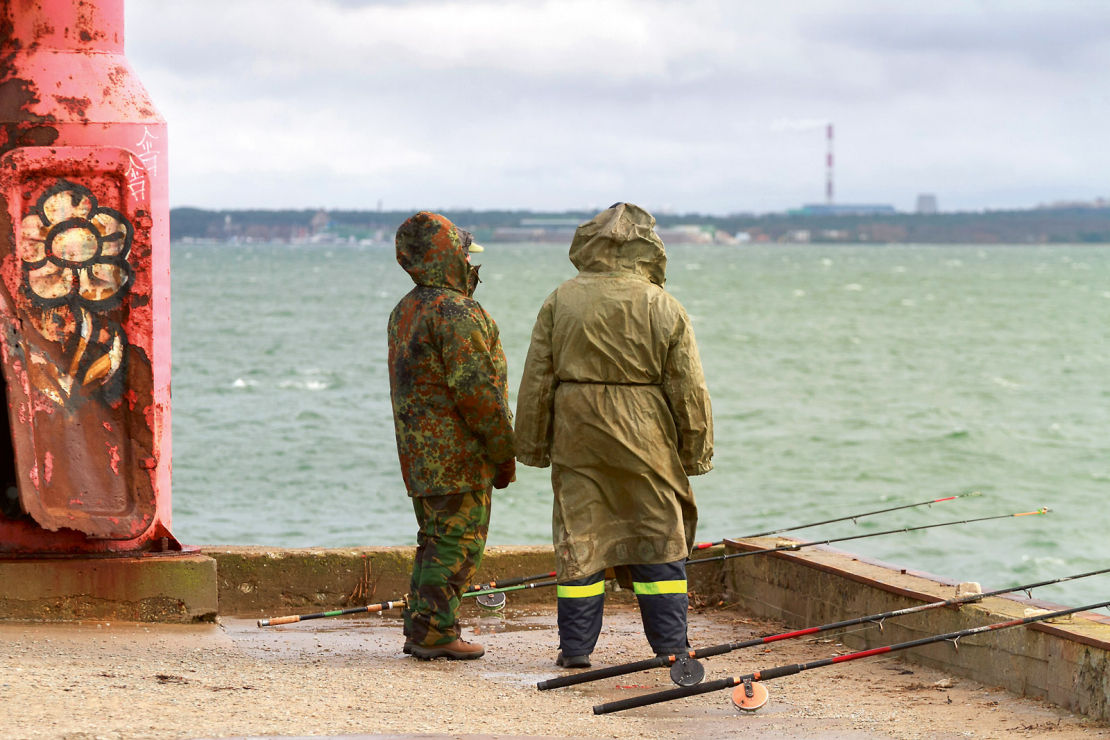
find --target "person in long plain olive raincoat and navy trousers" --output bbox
[516,203,713,668]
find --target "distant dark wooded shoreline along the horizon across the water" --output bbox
[170,207,1110,244]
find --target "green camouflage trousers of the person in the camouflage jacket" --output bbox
[404,488,491,646]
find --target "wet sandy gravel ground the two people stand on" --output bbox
[0,605,1110,740]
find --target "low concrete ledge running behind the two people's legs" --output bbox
[203,545,724,617]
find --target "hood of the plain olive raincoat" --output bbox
[572,203,667,287]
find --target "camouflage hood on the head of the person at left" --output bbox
[396,211,477,295]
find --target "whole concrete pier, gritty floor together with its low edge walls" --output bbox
[0,540,1110,740]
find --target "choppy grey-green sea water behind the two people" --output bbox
[173,244,1110,604]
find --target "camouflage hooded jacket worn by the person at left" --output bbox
[389,213,514,496]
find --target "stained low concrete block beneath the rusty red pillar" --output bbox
[0,554,218,624]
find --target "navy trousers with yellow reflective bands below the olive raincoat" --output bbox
[557,560,689,658]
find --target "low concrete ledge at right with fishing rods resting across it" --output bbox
[725,539,1110,720]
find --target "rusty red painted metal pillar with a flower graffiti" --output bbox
[0,0,179,554]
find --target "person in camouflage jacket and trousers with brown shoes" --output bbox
[389,213,516,660]
